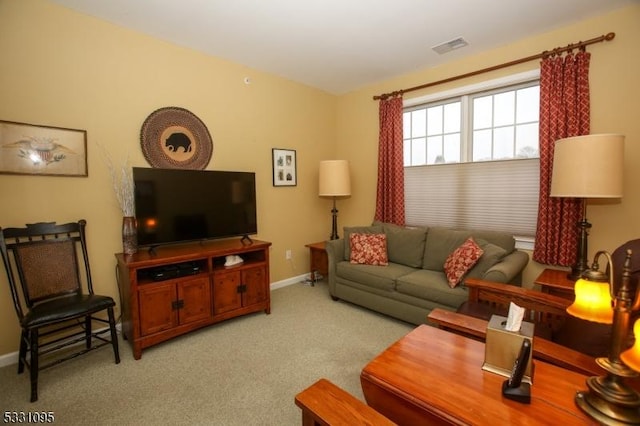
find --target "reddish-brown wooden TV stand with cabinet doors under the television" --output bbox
[116,239,271,359]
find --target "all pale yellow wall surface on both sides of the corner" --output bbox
[0,0,640,355]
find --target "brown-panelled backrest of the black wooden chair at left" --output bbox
[0,220,93,318]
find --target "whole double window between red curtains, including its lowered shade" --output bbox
[403,74,540,240]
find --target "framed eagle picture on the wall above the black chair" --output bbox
[0,120,89,177]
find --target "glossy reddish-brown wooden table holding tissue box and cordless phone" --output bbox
[360,325,594,426]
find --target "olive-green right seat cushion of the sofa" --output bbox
[396,269,469,309]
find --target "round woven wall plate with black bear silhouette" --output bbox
[140,107,213,170]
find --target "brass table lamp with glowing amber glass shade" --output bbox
[567,250,640,425]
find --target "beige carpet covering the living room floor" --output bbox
[0,282,413,425]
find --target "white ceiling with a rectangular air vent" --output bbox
[51,0,638,94]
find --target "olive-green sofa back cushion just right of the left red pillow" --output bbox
[373,221,427,268]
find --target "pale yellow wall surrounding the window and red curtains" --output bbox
[337,4,640,283]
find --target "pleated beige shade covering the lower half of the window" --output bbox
[404,158,540,237]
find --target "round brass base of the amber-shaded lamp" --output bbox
[575,375,640,425]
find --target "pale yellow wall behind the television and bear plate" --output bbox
[0,0,336,355]
